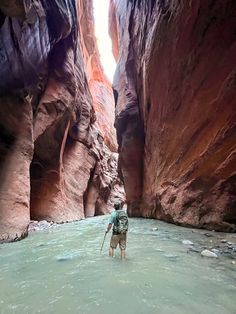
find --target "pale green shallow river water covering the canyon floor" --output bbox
[0,216,236,314]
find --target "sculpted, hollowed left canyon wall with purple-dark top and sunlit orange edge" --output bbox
[0,0,123,242]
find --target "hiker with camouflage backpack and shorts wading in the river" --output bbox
[106,203,129,259]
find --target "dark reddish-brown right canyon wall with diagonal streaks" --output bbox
[110,0,236,231]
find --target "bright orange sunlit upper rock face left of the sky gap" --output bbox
[78,0,117,152]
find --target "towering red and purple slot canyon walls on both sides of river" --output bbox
[0,0,236,242]
